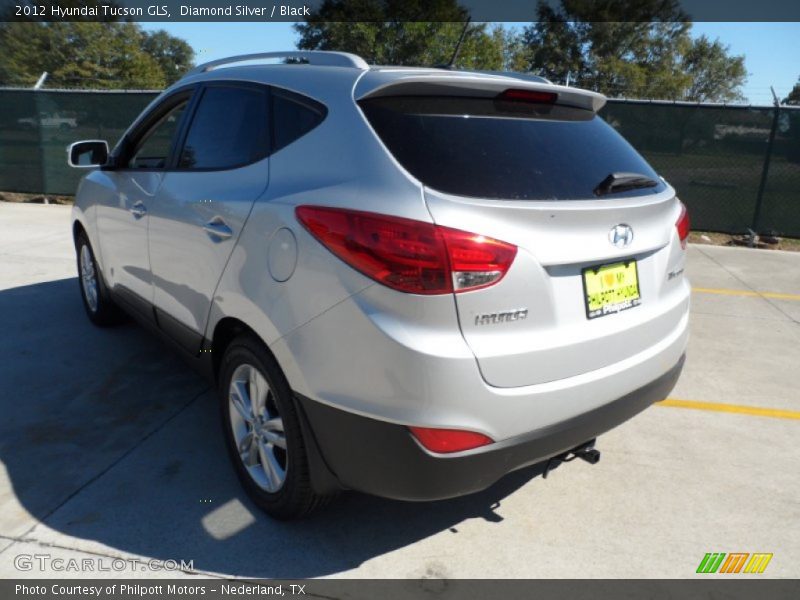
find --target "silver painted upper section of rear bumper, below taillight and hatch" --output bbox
[270,284,689,440]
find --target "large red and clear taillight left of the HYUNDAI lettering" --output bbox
[296,206,517,294]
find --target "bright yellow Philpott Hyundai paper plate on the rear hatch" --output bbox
[583,260,642,319]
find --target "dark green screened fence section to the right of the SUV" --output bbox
[601,100,800,237]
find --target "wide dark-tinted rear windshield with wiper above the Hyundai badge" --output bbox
[359,96,666,200]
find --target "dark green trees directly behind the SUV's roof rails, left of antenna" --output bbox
[295,0,506,70]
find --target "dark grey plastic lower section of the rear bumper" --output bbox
[298,356,684,500]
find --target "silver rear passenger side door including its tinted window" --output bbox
[149,82,270,352]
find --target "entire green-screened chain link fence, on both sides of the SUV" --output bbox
[0,89,800,237]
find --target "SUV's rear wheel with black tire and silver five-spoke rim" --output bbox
[219,334,329,520]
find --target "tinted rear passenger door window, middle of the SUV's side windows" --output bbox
[178,86,269,169]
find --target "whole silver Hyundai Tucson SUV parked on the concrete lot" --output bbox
[69,52,689,518]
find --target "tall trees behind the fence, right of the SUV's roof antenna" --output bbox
[522,0,746,101]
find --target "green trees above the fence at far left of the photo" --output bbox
[0,21,193,89]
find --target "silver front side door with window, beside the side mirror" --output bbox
[97,91,191,317]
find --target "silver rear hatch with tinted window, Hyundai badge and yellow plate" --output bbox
[359,75,686,387]
